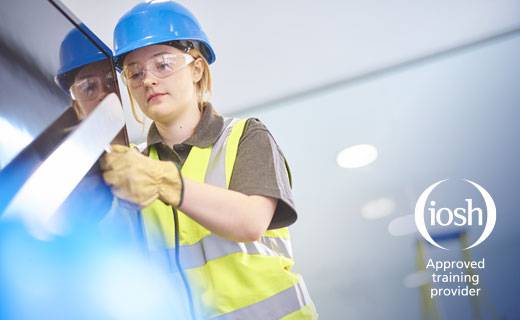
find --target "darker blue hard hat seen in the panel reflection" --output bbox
[56,24,112,92]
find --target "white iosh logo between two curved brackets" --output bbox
[415,179,497,250]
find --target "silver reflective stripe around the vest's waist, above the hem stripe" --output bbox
[167,234,293,270]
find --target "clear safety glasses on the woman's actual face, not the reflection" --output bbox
[123,53,195,89]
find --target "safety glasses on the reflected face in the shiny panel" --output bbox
[70,72,115,101]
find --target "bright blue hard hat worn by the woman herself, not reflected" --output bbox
[114,1,215,69]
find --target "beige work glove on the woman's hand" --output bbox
[101,145,183,208]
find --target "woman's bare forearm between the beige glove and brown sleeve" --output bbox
[179,178,278,242]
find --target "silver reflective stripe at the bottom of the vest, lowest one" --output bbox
[212,278,312,320]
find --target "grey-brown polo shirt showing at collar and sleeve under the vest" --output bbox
[145,103,297,229]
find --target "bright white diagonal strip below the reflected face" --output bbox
[4,94,124,237]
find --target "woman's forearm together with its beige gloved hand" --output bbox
[101,145,278,242]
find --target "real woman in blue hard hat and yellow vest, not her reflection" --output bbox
[102,1,317,320]
